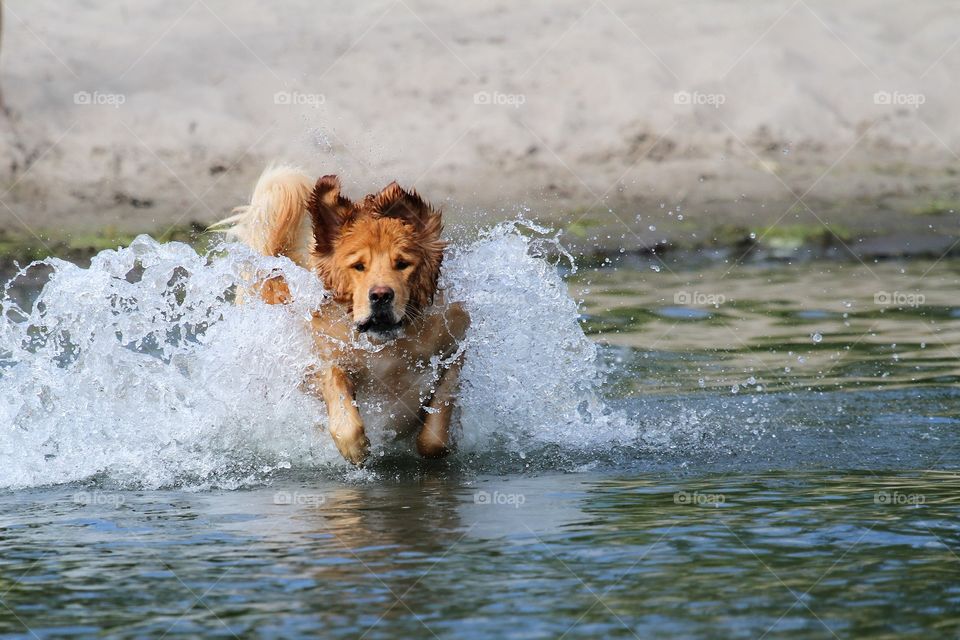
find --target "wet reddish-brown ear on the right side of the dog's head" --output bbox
[364,182,446,309]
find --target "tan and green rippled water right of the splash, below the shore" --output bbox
[574,260,960,393]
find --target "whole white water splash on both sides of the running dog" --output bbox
[0,223,633,488]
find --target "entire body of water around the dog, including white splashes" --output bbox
[0,225,960,638]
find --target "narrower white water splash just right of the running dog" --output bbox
[441,222,632,455]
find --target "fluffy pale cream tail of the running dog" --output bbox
[209,165,314,269]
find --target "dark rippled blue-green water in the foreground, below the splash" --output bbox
[0,471,960,638]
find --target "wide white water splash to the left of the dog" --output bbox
[0,236,342,487]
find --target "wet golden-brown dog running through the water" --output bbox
[221,166,470,465]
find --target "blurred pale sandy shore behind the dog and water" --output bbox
[0,0,960,255]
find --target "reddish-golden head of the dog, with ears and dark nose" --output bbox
[309,176,444,340]
